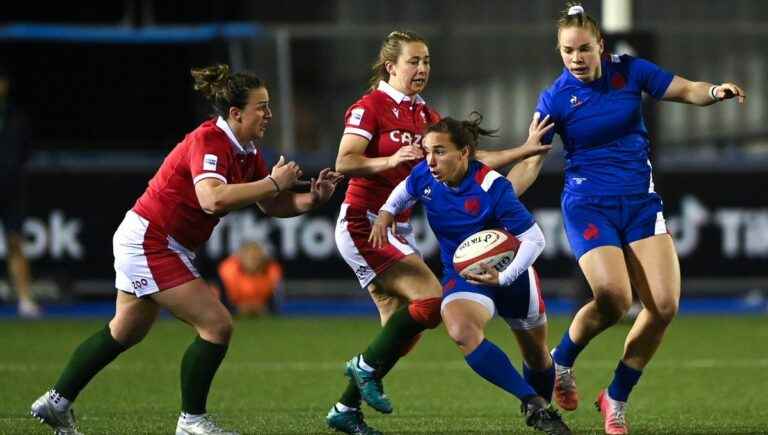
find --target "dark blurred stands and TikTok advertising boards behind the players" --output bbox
[0,0,768,314]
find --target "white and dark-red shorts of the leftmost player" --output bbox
[112,210,200,297]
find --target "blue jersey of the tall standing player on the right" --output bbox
[536,55,674,195]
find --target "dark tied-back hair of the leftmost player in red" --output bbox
[190,64,266,119]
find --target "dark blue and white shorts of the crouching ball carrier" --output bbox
[442,267,547,329]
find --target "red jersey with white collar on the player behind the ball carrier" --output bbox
[344,81,440,221]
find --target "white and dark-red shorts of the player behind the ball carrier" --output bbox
[336,203,419,288]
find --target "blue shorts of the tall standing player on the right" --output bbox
[560,192,668,259]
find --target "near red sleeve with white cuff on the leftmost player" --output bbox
[189,134,232,184]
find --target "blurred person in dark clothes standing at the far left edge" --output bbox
[0,66,42,318]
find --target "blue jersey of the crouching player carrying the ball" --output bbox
[405,160,534,273]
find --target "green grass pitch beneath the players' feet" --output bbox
[0,316,768,435]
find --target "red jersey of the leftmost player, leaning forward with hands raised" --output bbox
[133,118,269,250]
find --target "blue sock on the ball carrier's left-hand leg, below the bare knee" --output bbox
[464,340,536,401]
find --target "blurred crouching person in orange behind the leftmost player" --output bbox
[219,242,283,316]
